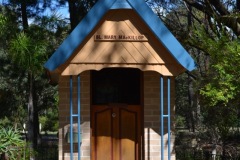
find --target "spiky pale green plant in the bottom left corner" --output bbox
[0,127,25,160]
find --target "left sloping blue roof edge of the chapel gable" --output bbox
[44,0,115,71]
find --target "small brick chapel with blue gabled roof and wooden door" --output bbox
[44,0,196,160]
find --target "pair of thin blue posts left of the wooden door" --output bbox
[69,75,81,160]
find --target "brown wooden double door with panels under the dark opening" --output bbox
[91,104,142,160]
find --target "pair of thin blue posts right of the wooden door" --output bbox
[160,76,171,160]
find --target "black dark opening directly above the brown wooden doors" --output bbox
[91,68,141,105]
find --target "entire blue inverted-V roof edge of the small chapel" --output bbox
[44,0,196,71]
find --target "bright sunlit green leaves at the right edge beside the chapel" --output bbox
[200,40,240,106]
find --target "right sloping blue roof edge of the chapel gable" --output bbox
[127,0,196,71]
